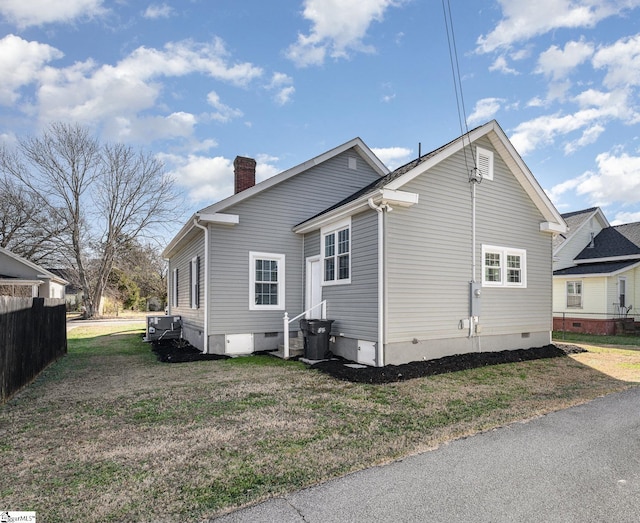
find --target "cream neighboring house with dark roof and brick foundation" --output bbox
[553,209,640,334]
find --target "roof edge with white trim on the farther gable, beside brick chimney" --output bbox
[162,137,389,258]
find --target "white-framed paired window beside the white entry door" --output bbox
[321,218,351,285]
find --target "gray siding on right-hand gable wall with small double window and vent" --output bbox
[386,139,552,343]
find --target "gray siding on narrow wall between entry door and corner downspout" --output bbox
[317,211,378,341]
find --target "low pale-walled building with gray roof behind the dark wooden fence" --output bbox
[0,247,68,298]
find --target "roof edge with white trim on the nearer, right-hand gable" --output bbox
[294,120,566,232]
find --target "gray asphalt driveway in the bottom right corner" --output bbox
[215,388,640,523]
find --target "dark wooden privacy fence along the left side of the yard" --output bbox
[0,296,67,403]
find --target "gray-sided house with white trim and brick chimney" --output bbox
[163,121,566,366]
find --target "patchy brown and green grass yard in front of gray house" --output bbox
[0,325,640,522]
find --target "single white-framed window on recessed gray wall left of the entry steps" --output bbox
[249,252,284,311]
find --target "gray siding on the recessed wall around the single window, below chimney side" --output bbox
[209,151,378,335]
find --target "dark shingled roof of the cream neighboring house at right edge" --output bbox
[575,222,640,263]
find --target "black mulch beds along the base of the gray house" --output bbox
[152,342,586,384]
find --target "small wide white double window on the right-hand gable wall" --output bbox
[482,245,527,287]
